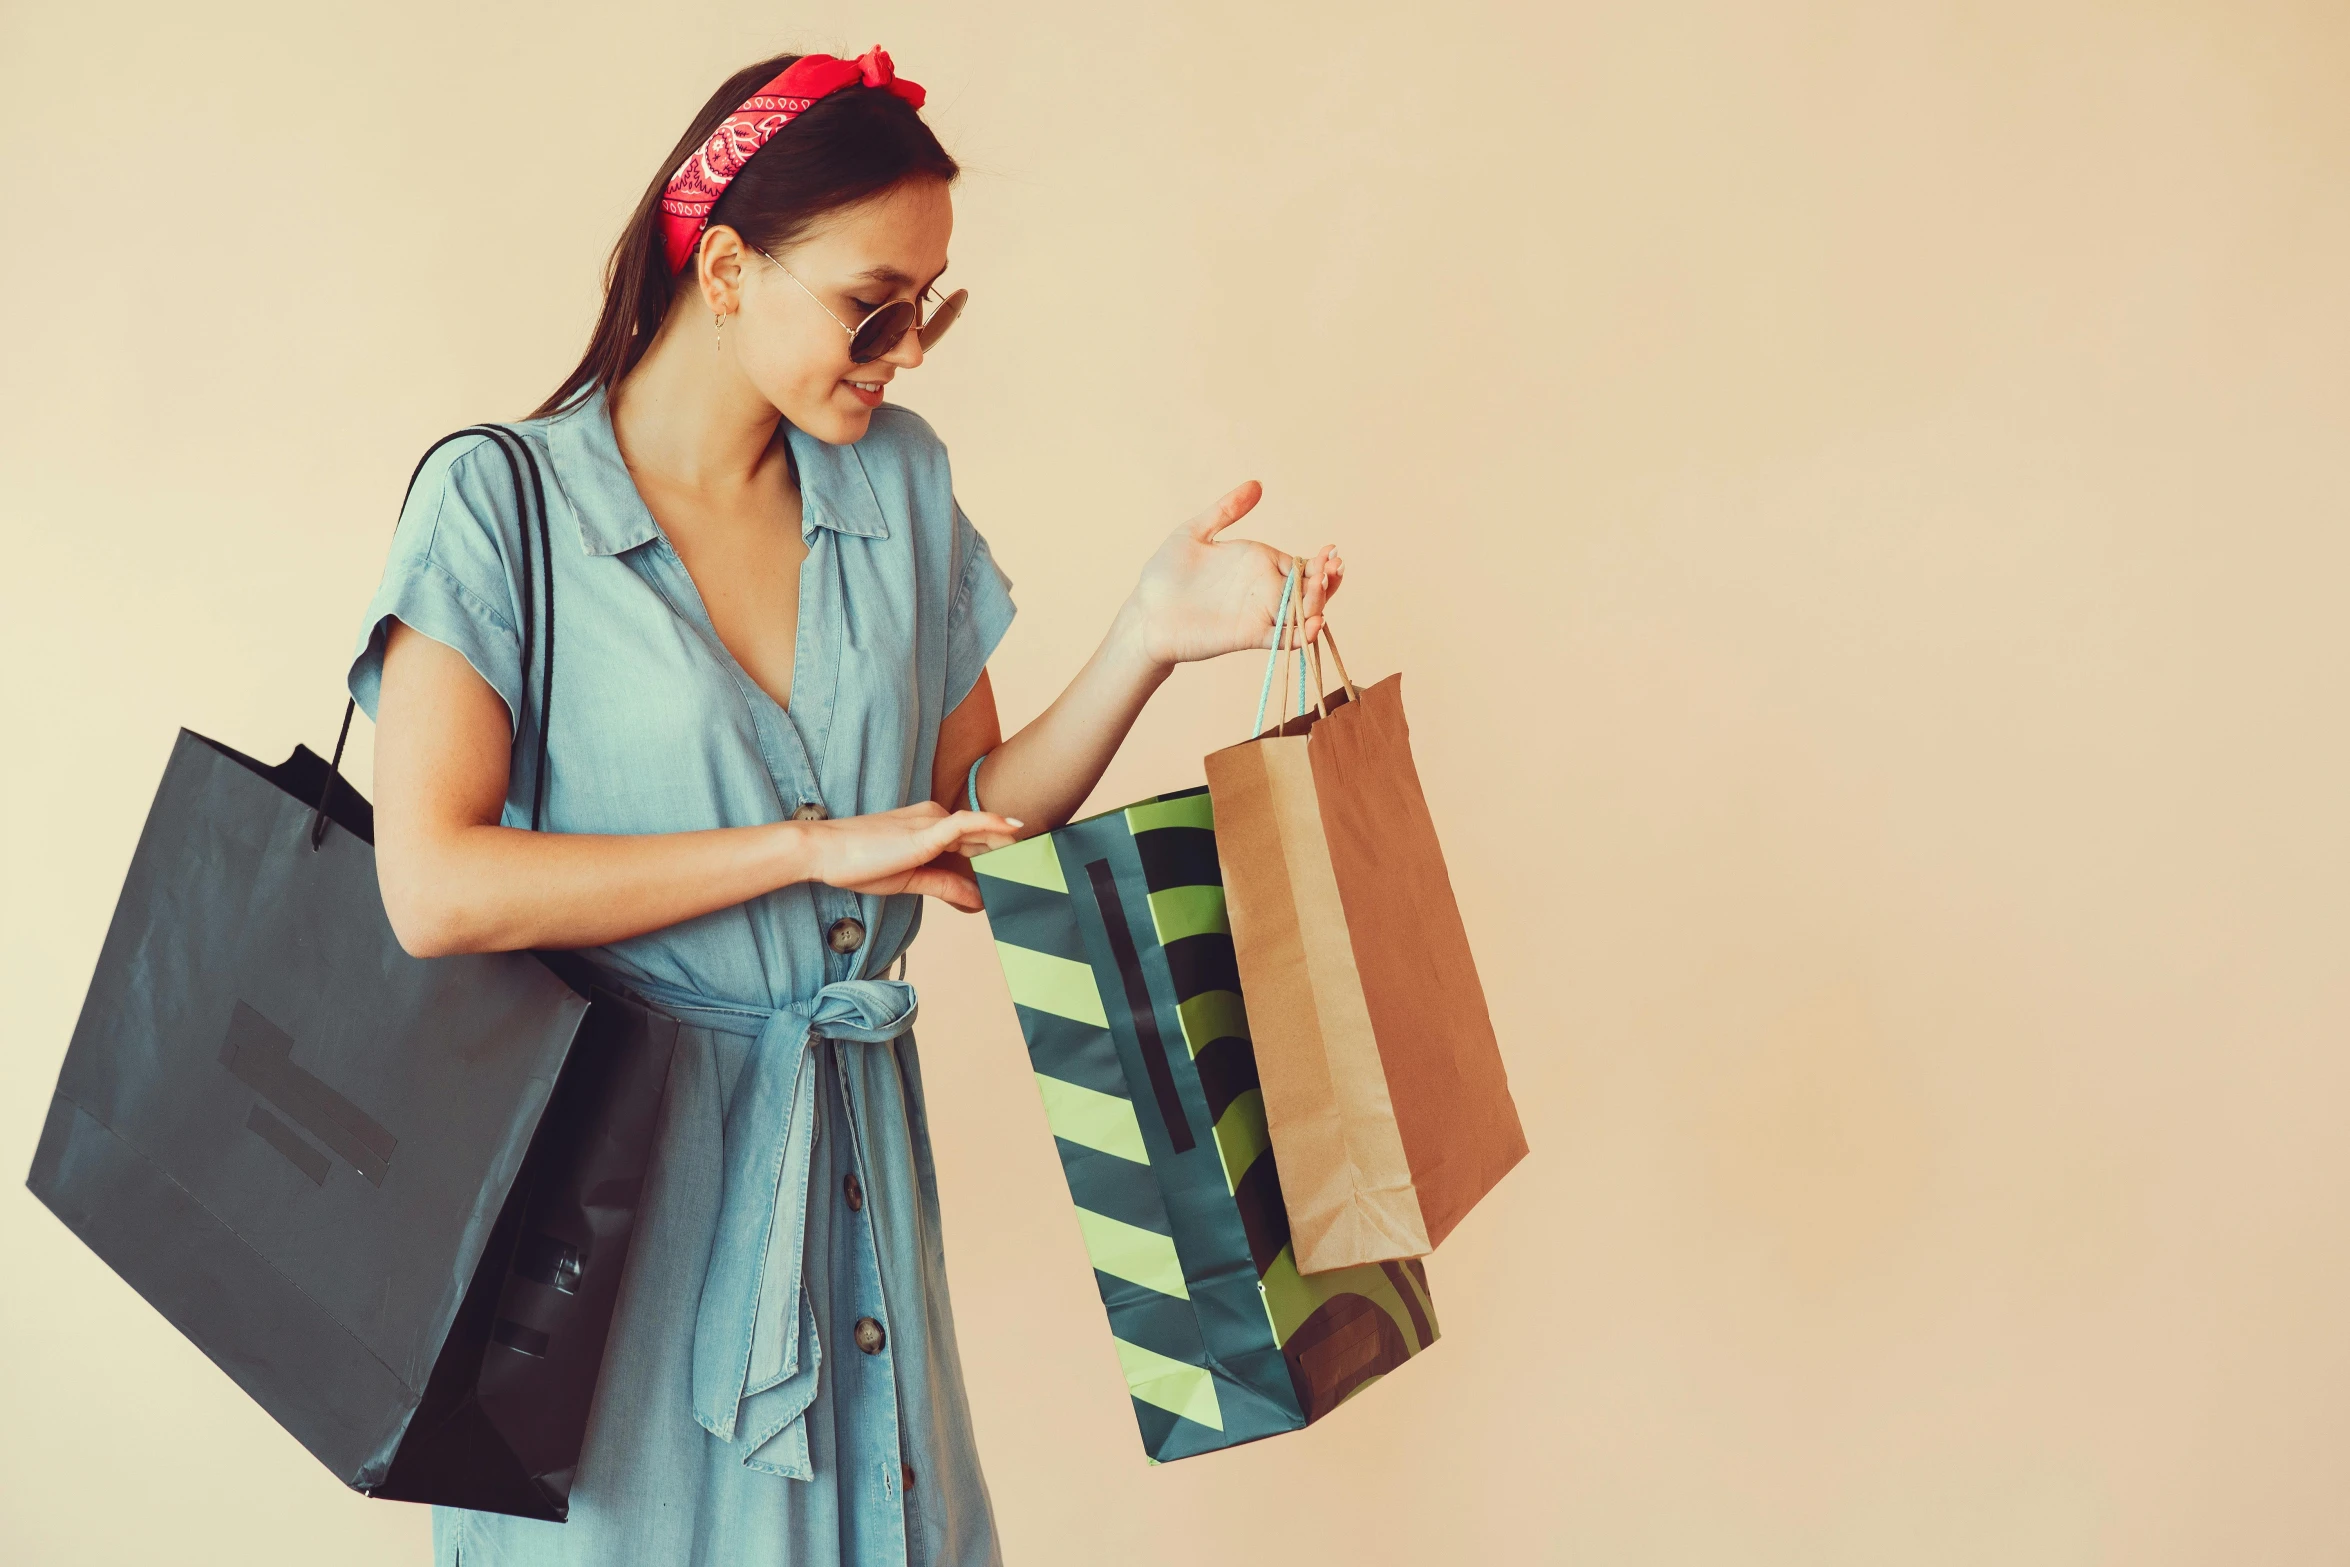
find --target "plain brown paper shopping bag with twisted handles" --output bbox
[1208,575,1525,1273]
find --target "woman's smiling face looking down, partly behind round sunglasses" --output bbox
[705,179,954,446]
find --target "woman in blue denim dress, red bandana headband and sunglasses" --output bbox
[350,49,1340,1567]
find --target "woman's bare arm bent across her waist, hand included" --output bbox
[376,623,1018,956]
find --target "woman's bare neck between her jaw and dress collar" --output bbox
[611,305,787,496]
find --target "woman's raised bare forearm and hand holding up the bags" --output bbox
[931,479,1344,836]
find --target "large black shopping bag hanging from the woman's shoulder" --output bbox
[28,428,677,1520]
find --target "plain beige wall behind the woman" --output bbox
[0,0,2350,1567]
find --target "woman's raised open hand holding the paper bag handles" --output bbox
[1126,479,1347,665]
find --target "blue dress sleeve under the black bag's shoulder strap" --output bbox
[350,437,522,726]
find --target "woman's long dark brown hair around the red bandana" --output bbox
[531,54,961,418]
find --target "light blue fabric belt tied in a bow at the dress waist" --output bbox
[630,980,917,1480]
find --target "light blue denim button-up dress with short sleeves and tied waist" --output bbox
[350,397,1013,1567]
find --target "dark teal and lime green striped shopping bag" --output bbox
[971,789,1436,1461]
